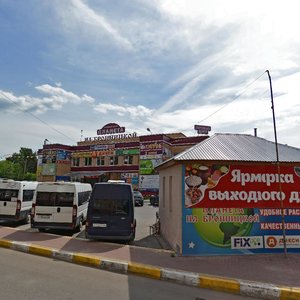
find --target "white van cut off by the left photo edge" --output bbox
[0,179,38,223]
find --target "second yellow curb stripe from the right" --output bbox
[199,276,240,294]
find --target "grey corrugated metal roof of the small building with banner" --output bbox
[172,133,300,162]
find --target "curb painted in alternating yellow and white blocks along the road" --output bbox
[0,239,300,300]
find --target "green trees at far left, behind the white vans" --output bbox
[0,148,37,180]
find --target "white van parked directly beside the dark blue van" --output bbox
[31,182,92,231]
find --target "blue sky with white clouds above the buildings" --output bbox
[0,0,300,159]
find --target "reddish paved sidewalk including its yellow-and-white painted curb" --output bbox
[0,227,300,299]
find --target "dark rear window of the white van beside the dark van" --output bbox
[36,192,74,207]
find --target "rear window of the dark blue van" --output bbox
[91,184,132,216]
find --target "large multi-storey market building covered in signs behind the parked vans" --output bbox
[37,123,208,195]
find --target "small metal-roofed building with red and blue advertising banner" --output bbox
[156,134,300,256]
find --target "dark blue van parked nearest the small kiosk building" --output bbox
[85,182,136,242]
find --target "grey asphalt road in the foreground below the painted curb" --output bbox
[0,248,254,300]
